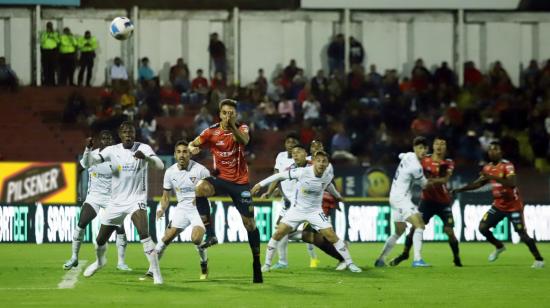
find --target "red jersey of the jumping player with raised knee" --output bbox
[199,123,248,184]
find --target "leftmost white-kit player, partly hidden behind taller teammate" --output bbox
[63,130,132,271]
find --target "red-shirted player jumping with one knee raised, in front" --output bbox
[189,99,263,283]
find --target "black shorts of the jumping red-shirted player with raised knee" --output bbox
[205,176,254,217]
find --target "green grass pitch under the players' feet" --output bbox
[0,243,550,308]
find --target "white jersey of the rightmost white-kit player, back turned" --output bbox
[390,152,427,200]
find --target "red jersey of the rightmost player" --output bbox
[483,159,523,212]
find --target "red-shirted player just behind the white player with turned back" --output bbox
[390,137,462,267]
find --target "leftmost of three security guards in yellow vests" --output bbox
[40,22,59,86]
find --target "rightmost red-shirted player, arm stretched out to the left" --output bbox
[453,141,544,268]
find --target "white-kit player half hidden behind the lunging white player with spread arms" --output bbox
[261,132,300,269]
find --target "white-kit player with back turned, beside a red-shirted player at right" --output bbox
[374,137,444,267]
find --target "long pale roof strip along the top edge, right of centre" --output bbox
[301,0,520,11]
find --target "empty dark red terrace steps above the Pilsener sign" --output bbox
[0,87,95,161]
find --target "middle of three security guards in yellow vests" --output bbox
[59,27,78,86]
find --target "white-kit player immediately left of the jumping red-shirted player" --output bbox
[141,140,210,280]
